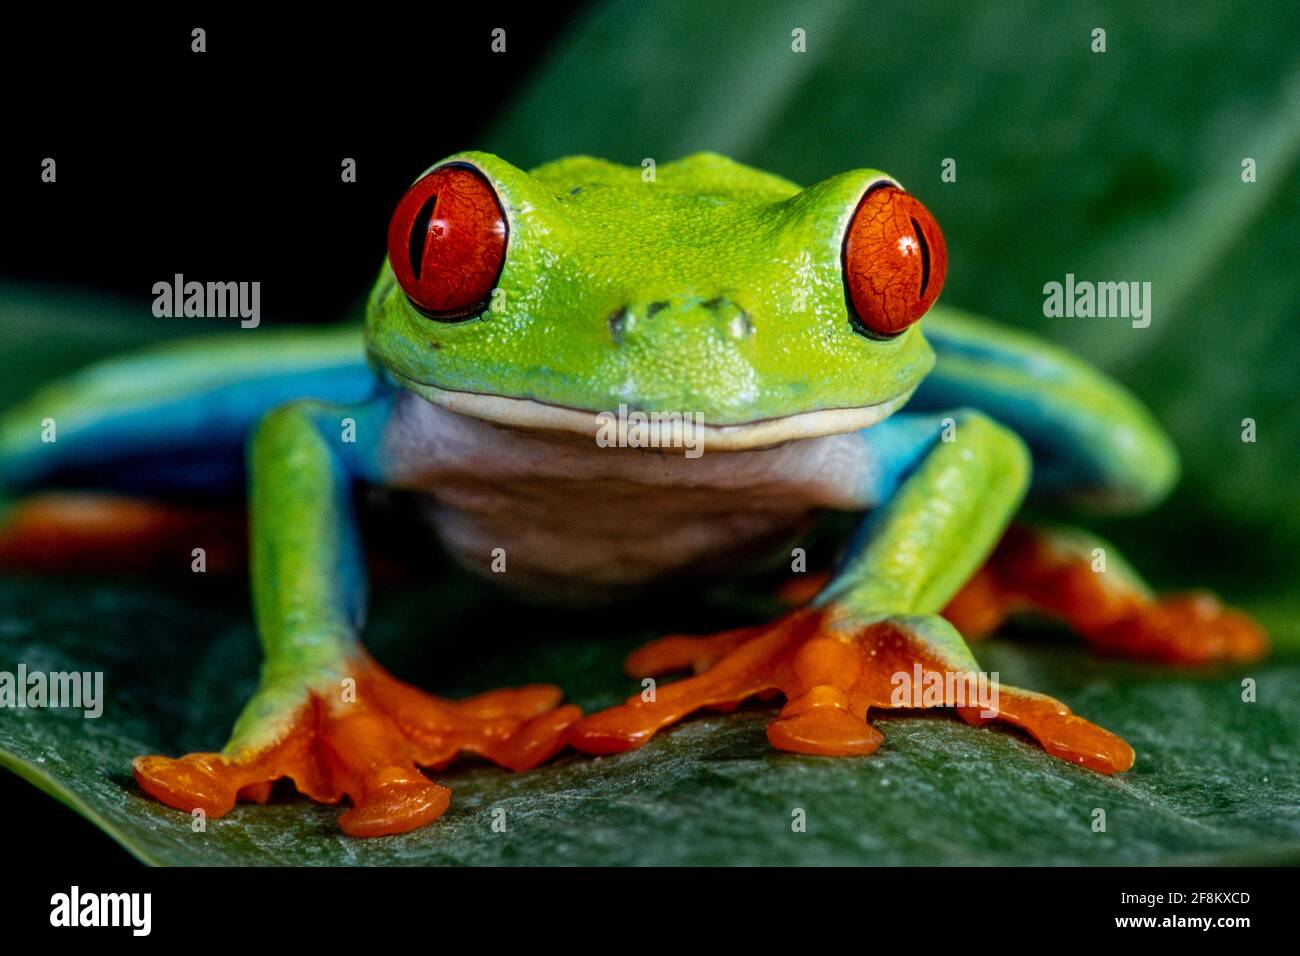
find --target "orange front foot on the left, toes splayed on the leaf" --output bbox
[133,654,580,836]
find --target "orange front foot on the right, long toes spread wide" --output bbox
[568,605,1134,773]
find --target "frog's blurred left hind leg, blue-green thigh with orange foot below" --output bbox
[0,328,378,572]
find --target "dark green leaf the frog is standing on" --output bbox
[0,579,1300,865]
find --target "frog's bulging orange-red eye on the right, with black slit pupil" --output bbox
[844,183,948,337]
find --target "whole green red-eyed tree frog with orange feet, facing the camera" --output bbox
[0,151,1268,838]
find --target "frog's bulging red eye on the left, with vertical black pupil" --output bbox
[389,164,507,320]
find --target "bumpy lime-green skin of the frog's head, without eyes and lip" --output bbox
[367,152,933,425]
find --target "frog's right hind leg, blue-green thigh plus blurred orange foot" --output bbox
[910,308,1265,663]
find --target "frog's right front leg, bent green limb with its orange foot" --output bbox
[568,411,1134,773]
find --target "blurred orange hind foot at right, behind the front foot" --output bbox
[944,523,1268,663]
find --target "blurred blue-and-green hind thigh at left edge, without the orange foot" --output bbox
[0,328,378,499]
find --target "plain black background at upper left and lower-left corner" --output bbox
[0,3,577,865]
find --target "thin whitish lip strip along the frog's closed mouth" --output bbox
[387,369,917,451]
